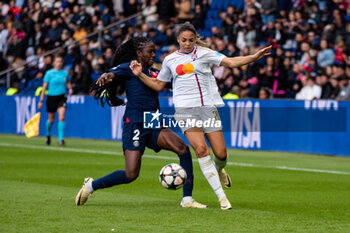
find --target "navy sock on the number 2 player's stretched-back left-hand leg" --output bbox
[91,170,130,190]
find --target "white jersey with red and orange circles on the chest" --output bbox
[157,46,225,107]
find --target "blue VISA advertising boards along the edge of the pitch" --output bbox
[0,96,350,156]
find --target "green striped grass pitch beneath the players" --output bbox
[0,135,350,232]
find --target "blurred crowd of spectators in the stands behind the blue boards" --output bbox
[0,0,350,100]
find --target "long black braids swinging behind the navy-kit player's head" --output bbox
[90,37,152,107]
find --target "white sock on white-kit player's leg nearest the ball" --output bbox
[198,155,226,200]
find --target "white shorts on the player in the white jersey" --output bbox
[174,106,222,133]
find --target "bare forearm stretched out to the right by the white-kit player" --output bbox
[220,46,272,68]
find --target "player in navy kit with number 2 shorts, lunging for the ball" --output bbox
[75,37,207,208]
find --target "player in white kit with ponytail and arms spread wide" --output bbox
[130,23,271,210]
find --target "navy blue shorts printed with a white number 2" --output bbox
[123,122,162,153]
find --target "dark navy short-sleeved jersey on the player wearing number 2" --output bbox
[109,62,159,122]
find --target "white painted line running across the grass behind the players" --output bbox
[0,142,350,175]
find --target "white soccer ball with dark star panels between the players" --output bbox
[159,163,187,190]
